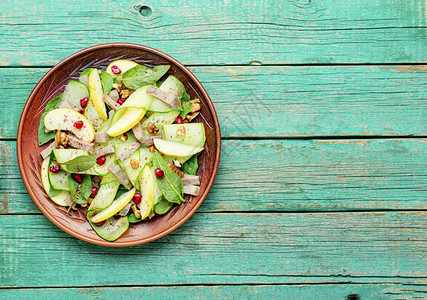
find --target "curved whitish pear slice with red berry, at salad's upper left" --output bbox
[44,108,95,143]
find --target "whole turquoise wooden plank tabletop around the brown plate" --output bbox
[0,0,427,300]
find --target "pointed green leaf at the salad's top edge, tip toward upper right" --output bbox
[122,65,170,90]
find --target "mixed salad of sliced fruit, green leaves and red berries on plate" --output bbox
[38,60,206,241]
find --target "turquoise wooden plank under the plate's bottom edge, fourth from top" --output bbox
[0,212,427,288]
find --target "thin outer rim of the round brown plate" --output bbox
[16,43,221,247]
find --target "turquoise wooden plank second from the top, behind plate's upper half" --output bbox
[0,66,427,138]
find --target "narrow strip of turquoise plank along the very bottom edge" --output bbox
[0,283,427,300]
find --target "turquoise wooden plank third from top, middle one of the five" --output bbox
[0,139,427,213]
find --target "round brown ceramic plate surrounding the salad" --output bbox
[17,43,221,247]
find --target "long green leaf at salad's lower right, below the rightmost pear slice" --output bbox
[153,151,185,204]
